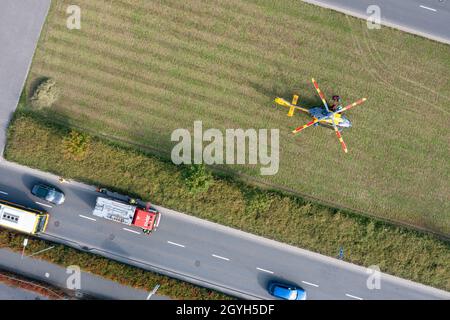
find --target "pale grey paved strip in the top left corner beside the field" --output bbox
[0,0,50,156]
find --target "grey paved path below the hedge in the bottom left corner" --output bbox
[0,248,167,300]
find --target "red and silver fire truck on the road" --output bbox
[92,189,161,234]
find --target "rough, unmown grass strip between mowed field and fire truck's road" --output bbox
[5,111,450,292]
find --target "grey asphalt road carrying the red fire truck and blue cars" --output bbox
[0,161,450,299]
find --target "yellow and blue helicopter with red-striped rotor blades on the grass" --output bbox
[275,78,367,153]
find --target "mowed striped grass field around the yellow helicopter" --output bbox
[27,0,450,234]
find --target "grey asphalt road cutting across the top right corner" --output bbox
[303,0,450,44]
